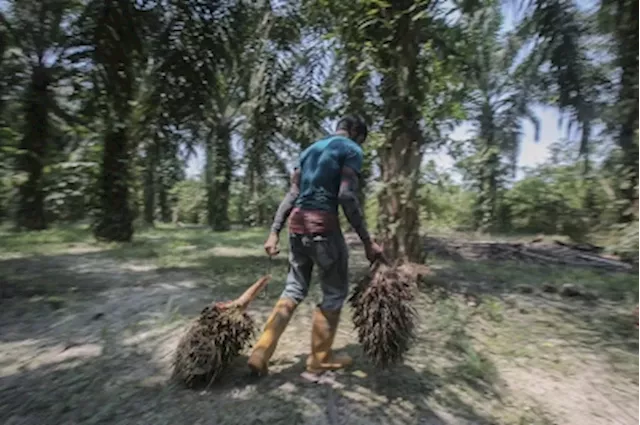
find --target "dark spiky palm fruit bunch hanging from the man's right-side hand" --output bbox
[349,260,417,369]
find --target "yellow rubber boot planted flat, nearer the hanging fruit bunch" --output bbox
[307,308,353,374]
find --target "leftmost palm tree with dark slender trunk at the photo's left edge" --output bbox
[0,0,80,230]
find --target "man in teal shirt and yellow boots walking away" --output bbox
[249,116,382,375]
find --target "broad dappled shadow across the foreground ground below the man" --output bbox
[0,335,500,425]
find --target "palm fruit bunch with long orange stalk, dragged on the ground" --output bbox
[173,276,270,388]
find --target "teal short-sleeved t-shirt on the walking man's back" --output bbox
[295,135,363,213]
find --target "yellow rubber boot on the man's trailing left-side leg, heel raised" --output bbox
[248,298,297,375]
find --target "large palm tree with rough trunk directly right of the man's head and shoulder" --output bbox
[360,0,472,262]
